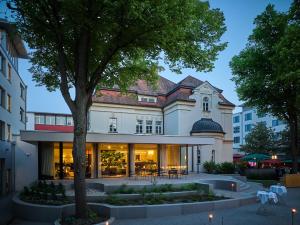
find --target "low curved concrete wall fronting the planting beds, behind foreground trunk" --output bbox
[13,196,256,222]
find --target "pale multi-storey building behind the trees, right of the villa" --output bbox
[232,106,286,154]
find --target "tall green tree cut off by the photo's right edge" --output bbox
[230,0,300,172]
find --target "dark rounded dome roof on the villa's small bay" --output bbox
[191,118,224,134]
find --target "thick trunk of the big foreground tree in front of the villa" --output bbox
[73,98,88,218]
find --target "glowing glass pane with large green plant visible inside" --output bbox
[99,144,128,177]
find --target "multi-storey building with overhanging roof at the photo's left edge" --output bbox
[0,19,28,196]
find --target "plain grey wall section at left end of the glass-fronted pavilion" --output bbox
[14,136,38,191]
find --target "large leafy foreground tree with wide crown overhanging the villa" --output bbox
[7,0,226,218]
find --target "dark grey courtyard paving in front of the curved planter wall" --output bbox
[8,188,300,225]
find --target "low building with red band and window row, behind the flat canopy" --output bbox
[26,112,74,132]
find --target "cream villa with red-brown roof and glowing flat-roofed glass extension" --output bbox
[17,76,234,188]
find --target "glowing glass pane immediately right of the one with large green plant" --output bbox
[134,144,158,175]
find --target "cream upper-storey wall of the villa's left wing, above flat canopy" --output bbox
[89,104,163,134]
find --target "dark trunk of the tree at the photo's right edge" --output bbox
[290,119,298,173]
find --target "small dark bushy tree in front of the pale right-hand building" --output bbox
[241,123,277,154]
